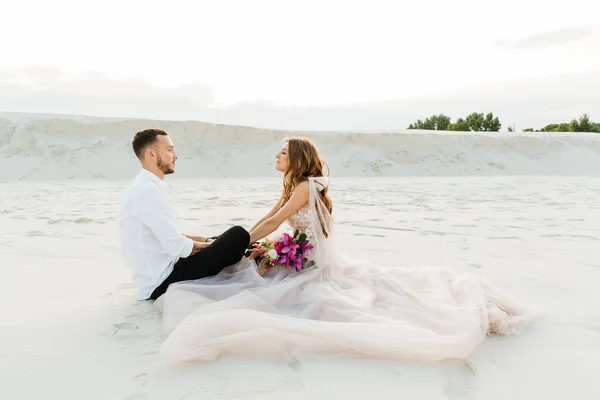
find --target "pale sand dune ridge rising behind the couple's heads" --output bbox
[0,113,600,181]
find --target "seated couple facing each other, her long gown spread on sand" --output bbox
[118,129,534,362]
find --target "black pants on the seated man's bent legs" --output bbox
[150,226,250,300]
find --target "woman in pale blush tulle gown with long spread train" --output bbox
[159,138,532,361]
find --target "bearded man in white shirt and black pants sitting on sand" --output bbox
[118,129,250,300]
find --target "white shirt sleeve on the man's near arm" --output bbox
[136,188,194,258]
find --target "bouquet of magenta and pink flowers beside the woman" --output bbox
[244,231,315,276]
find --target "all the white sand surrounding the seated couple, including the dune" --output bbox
[0,111,600,400]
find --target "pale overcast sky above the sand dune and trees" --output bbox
[0,0,600,130]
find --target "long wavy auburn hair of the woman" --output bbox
[280,137,333,237]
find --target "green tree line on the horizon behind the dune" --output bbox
[408,112,600,133]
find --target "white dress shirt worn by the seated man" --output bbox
[118,168,194,300]
